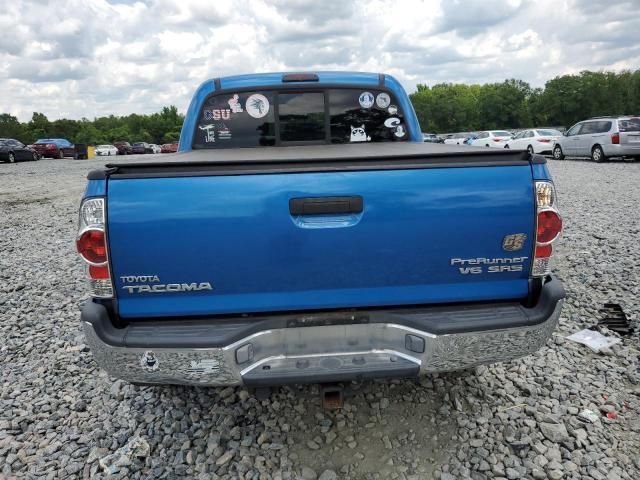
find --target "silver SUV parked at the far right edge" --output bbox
[552,115,640,162]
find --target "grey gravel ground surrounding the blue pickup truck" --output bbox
[0,156,640,480]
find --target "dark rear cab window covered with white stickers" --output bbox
[193,88,409,149]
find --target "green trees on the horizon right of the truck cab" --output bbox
[410,70,640,133]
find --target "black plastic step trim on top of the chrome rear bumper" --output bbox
[81,277,565,348]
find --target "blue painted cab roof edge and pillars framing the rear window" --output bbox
[178,72,423,152]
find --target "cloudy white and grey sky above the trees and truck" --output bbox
[0,0,640,121]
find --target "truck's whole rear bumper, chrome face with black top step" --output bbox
[81,279,564,386]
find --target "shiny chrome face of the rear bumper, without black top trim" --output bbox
[83,300,563,386]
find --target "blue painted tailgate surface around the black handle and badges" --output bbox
[108,165,534,317]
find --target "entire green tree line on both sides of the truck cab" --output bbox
[0,70,640,145]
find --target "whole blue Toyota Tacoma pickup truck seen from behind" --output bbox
[77,72,564,387]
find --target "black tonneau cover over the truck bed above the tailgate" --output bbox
[88,142,546,180]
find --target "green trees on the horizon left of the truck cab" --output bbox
[0,105,184,145]
